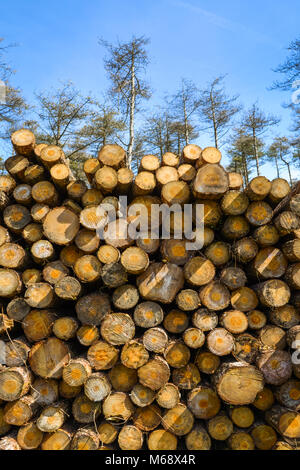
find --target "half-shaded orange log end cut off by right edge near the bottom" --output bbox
[266,405,300,439]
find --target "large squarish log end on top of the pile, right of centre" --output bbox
[193,164,229,199]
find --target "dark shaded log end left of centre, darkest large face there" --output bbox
[75,292,111,326]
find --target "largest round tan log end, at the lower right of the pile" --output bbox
[214,362,264,405]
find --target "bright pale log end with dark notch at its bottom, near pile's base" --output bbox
[103,392,135,424]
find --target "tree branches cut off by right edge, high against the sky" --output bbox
[272,38,300,90]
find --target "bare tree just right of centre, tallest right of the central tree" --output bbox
[198,76,241,148]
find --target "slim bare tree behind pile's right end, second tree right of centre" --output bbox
[242,103,279,175]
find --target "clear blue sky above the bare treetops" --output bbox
[0,0,300,176]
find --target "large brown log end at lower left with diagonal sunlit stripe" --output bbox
[29,337,70,379]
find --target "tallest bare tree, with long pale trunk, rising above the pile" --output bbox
[99,36,150,167]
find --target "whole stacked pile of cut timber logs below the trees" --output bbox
[0,129,300,450]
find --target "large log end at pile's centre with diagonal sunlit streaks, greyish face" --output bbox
[137,263,184,304]
